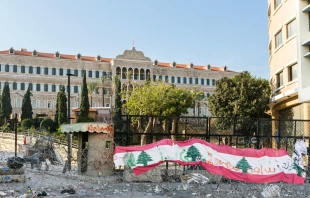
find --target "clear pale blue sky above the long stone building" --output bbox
[0,0,269,79]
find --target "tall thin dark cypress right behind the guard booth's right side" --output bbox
[113,75,123,132]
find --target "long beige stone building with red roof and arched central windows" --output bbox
[0,47,237,118]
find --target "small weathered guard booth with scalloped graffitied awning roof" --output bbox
[61,122,114,176]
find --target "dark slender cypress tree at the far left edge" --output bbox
[0,82,12,120]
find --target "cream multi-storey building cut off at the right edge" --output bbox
[268,0,310,119]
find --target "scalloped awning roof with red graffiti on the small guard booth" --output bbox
[61,122,113,133]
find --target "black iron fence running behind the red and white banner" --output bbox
[115,115,310,154]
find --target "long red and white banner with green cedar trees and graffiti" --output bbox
[114,139,305,184]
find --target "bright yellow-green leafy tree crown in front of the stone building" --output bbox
[124,82,196,116]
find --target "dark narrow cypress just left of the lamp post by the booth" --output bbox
[56,85,68,125]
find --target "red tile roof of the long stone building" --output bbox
[0,50,232,72]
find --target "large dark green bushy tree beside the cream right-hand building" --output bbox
[208,72,271,118]
